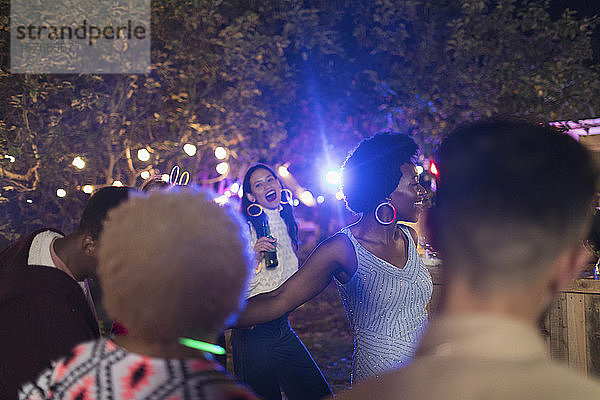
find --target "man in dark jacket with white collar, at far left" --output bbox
[0,186,128,400]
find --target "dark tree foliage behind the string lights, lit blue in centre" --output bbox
[0,0,600,239]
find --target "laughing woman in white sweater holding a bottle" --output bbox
[231,164,331,400]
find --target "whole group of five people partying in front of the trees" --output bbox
[0,119,600,400]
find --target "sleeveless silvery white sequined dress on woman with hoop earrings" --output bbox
[336,225,433,383]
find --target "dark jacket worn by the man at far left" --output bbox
[0,229,99,400]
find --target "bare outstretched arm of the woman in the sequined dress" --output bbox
[236,234,357,327]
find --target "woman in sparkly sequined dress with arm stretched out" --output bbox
[238,133,433,383]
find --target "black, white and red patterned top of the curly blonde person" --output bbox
[19,339,256,400]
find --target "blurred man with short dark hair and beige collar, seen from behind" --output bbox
[337,121,600,400]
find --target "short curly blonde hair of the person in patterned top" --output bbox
[98,188,254,342]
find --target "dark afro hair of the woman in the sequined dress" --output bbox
[342,132,422,213]
